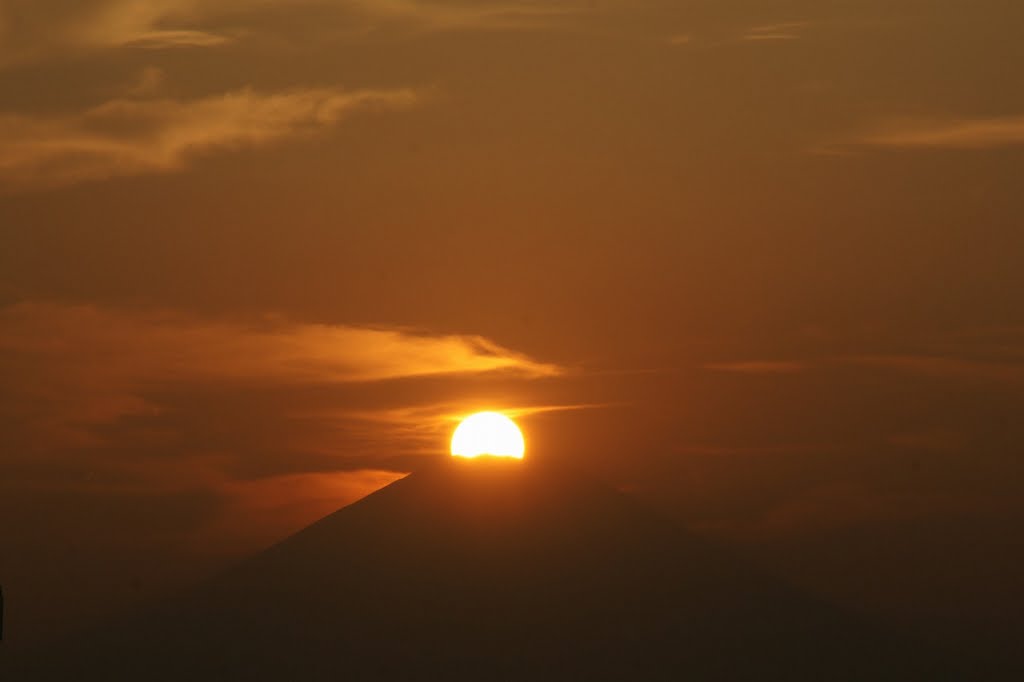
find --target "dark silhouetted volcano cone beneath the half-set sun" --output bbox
[9,461,950,682]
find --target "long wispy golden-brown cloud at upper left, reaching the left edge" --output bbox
[0,88,418,189]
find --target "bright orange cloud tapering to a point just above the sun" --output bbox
[0,303,561,423]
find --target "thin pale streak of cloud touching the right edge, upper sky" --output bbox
[853,116,1024,150]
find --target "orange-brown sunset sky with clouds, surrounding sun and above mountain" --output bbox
[0,0,1024,659]
